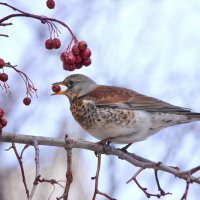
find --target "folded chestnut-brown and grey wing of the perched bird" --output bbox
[87,86,191,114]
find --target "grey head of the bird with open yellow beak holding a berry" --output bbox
[53,74,98,101]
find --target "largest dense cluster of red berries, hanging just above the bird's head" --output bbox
[60,41,92,71]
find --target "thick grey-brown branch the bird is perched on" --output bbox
[0,133,200,184]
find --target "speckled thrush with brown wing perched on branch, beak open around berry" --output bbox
[53,74,200,147]
